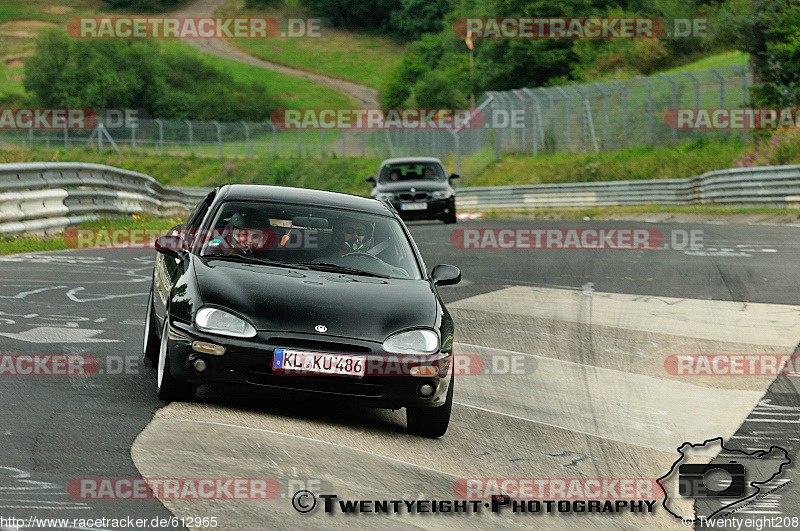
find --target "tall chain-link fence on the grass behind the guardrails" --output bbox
[0,65,751,172]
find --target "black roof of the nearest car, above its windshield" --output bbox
[219,184,393,216]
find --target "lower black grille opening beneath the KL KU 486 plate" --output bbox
[245,364,383,397]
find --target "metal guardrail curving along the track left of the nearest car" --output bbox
[0,162,209,234]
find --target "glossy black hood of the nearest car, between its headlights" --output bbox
[194,258,437,342]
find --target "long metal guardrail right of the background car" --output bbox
[456,165,800,211]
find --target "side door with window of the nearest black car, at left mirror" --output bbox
[153,190,217,327]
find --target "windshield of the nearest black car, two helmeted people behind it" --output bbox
[200,201,422,279]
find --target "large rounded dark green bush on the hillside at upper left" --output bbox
[24,31,278,121]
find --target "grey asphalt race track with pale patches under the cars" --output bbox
[0,220,800,529]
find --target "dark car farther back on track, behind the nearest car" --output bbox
[367,157,459,223]
